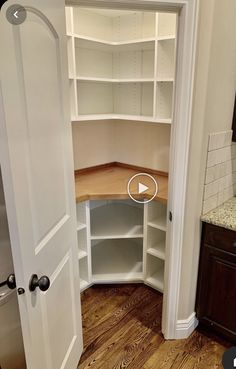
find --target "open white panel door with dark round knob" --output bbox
[0,0,83,369]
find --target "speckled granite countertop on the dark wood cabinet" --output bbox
[201,197,236,231]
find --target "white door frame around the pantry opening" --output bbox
[66,0,198,339]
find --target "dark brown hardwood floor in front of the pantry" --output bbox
[78,284,229,369]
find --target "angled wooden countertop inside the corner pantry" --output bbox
[75,163,168,203]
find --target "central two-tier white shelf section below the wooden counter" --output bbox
[90,200,143,283]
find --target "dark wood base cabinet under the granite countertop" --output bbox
[196,223,236,343]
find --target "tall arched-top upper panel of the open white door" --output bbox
[19,12,67,242]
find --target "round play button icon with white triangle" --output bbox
[127,173,158,204]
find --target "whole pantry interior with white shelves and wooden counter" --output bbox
[66,7,178,308]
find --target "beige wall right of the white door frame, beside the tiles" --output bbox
[178,0,236,319]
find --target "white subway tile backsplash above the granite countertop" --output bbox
[202,131,236,214]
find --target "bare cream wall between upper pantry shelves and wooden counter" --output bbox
[72,121,171,172]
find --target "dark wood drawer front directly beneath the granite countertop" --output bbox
[203,223,236,254]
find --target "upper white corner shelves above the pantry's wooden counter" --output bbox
[66,7,176,124]
